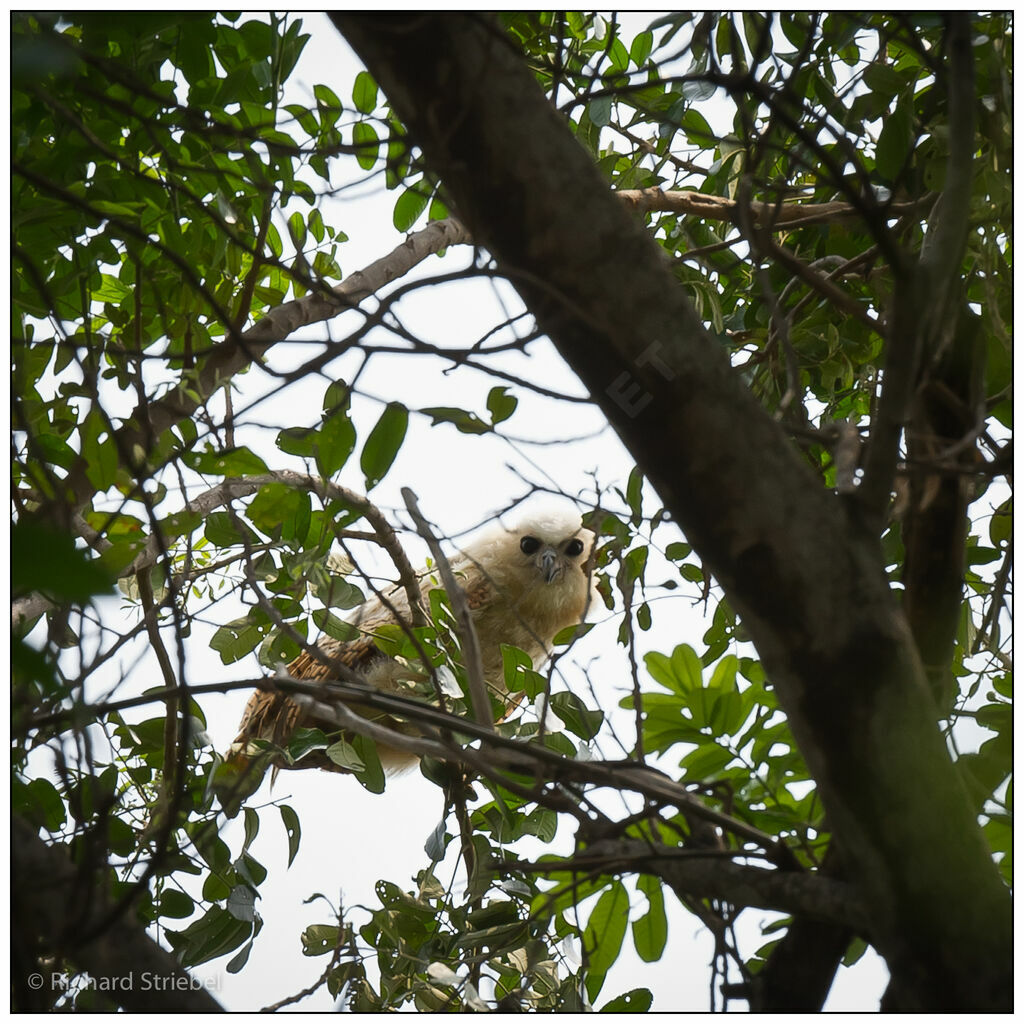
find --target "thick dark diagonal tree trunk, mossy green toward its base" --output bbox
[332,14,1012,1010]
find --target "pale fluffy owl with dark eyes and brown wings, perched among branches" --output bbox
[218,514,594,792]
